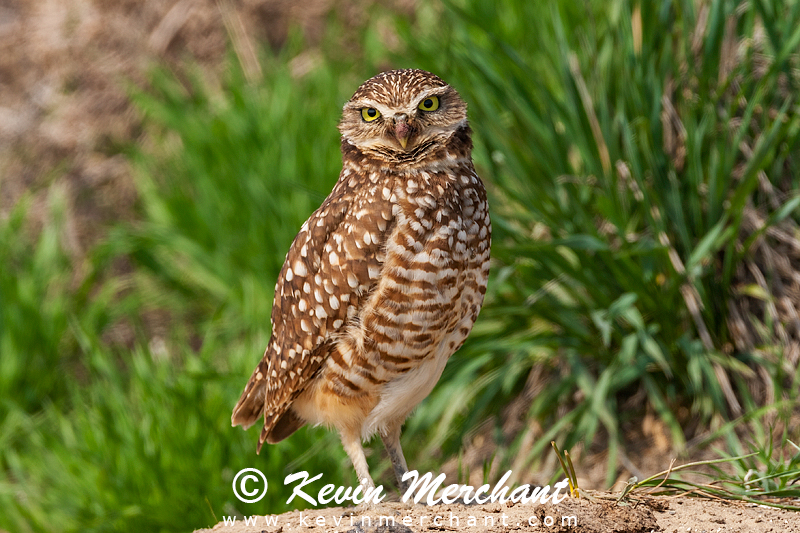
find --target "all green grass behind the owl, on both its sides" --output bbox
[0,0,800,531]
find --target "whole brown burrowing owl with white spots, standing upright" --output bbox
[232,70,491,494]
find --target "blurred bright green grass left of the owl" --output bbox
[0,32,388,531]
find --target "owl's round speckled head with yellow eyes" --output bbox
[339,69,472,163]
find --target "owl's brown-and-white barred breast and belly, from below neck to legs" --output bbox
[300,167,490,435]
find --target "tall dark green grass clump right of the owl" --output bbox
[404,1,800,483]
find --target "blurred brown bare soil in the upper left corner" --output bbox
[0,0,370,247]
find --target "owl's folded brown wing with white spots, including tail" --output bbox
[231,170,393,451]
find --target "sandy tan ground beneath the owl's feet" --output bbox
[195,497,800,533]
